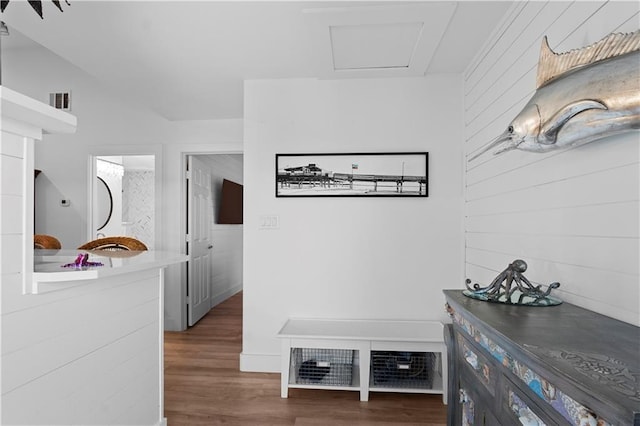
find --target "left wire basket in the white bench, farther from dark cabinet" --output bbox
[291,348,354,386]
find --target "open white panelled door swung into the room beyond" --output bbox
[187,155,213,326]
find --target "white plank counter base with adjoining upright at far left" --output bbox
[0,126,163,425]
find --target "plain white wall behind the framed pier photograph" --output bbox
[241,75,463,371]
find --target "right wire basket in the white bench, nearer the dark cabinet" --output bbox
[371,351,436,389]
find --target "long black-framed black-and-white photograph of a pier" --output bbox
[276,152,429,197]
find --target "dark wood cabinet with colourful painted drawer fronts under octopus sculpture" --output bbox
[444,290,640,426]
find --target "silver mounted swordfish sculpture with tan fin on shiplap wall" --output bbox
[469,30,640,161]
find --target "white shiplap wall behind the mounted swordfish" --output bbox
[465,1,640,325]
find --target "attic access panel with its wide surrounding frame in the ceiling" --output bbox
[303,2,456,78]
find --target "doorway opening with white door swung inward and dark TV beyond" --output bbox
[183,154,244,326]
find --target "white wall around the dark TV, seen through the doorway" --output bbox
[201,154,243,306]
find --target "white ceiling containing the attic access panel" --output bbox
[1,0,511,120]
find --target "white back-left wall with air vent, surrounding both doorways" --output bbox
[2,41,243,330]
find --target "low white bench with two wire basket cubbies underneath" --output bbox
[278,318,447,404]
